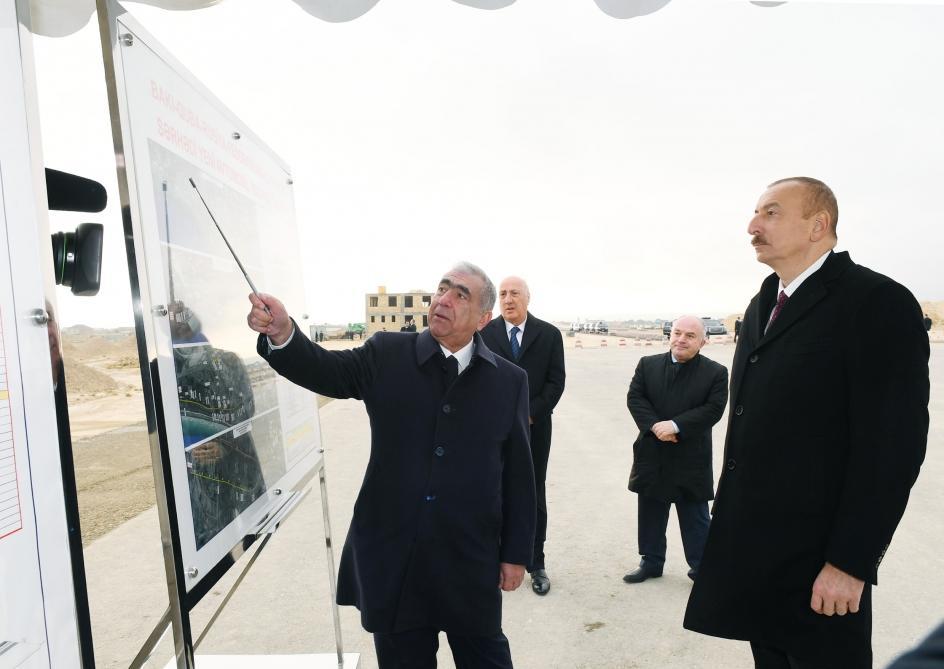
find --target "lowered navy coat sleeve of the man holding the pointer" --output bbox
[500,371,537,565]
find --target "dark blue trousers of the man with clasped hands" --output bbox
[638,495,709,574]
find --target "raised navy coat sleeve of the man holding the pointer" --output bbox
[256,320,383,399]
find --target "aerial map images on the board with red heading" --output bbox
[149,141,286,550]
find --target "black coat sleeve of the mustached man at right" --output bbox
[826,282,930,584]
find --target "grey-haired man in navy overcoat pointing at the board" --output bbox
[248,263,535,669]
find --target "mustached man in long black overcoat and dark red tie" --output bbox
[685,177,929,669]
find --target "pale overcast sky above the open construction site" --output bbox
[34,0,944,326]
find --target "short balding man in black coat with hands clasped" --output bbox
[623,316,728,583]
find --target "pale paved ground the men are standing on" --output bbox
[86,344,944,669]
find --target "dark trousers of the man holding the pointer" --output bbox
[374,627,514,669]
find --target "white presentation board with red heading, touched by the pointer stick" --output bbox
[107,13,321,591]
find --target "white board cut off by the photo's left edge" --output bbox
[0,2,81,668]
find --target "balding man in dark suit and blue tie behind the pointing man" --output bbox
[482,276,566,595]
